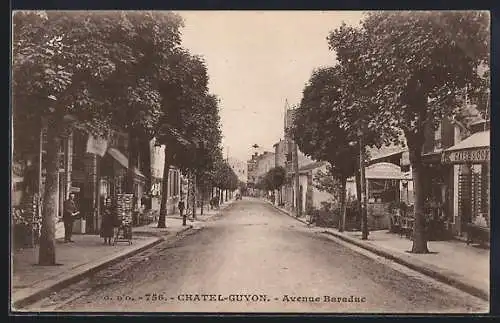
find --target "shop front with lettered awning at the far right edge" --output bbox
[441,131,491,246]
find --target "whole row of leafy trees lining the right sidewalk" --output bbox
[292,11,490,253]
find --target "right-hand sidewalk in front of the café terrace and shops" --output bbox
[268,201,490,300]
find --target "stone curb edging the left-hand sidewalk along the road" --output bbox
[11,226,192,312]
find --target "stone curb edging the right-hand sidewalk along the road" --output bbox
[321,230,490,301]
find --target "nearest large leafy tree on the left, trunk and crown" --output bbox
[13,11,191,265]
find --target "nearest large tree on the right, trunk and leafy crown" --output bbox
[329,11,489,253]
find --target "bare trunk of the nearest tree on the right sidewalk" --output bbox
[408,143,429,253]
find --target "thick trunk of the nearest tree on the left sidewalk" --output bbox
[38,121,61,266]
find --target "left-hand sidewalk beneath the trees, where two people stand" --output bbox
[11,219,192,308]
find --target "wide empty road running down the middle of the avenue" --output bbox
[28,199,488,313]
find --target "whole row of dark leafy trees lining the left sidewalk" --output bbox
[12,11,227,265]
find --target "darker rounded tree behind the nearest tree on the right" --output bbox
[291,65,389,231]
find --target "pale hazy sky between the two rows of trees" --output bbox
[179,11,362,161]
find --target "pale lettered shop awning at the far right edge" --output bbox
[441,130,490,164]
